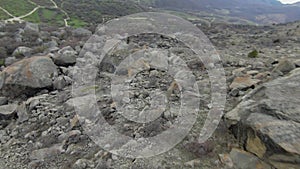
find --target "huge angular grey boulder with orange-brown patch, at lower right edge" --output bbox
[225,68,300,168]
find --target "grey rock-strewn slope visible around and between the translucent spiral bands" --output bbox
[0,22,300,169]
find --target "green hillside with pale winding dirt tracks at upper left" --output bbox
[0,0,146,27]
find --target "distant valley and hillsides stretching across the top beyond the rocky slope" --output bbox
[0,0,300,27]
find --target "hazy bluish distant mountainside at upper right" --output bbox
[146,0,300,24]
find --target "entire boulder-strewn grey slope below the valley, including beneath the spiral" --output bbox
[0,16,300,169]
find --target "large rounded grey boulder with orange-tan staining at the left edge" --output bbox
[0,56,57,96]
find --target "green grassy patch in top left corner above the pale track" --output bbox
[0,0,36,16]
